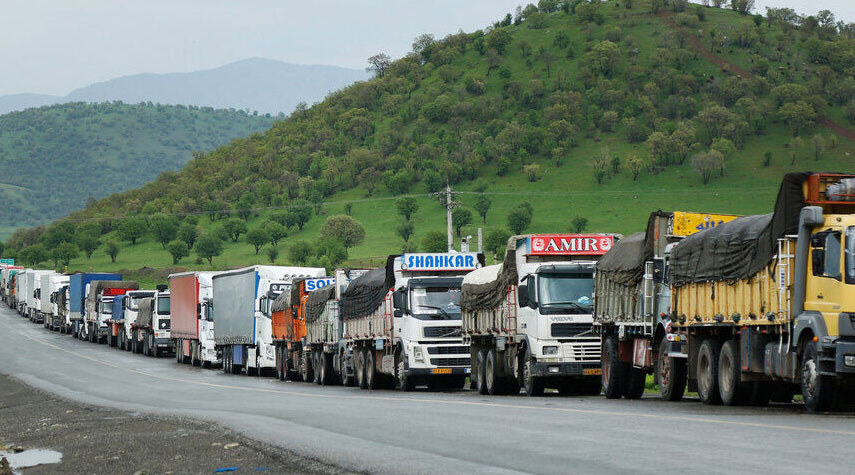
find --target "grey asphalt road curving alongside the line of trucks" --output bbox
[0,305,855,474]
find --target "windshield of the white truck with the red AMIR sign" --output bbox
[537,273,594,314]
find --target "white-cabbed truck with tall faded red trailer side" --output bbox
[169,271,220,368]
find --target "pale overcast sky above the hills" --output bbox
[0,0,855,95]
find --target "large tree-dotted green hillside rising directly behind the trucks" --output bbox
[7,0,855,280]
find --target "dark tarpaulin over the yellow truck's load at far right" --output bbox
[670,172,811,287]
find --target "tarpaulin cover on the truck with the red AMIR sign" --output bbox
[460,234,531,311]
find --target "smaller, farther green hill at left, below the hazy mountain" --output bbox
[0,102,273,237]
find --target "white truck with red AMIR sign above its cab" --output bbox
[462,234,619,396]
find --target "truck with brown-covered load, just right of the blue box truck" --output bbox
[83,280,139,346]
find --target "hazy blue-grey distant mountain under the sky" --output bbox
[0,58,369,114]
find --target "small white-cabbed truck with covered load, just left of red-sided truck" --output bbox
[126,284,173,358]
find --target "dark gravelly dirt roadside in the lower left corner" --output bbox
[0,375,352,475]
